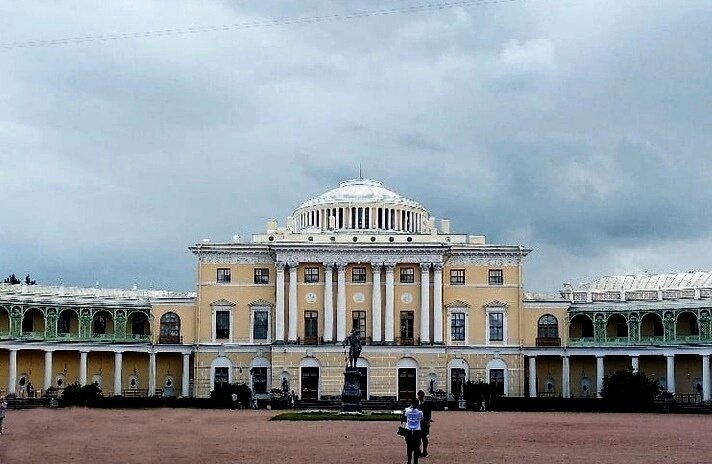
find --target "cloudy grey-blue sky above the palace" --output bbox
[0,0,712,292]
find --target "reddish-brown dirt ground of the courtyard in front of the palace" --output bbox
[0,408,712,464]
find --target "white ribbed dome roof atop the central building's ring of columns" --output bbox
[297,179,425,210]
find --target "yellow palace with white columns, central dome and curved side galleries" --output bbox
[0,179,712,401]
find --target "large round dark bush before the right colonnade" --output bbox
[601,369,658,411]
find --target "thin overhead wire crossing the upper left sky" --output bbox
[0,0,520,50]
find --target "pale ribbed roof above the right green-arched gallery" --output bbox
[574,271,712,292]
